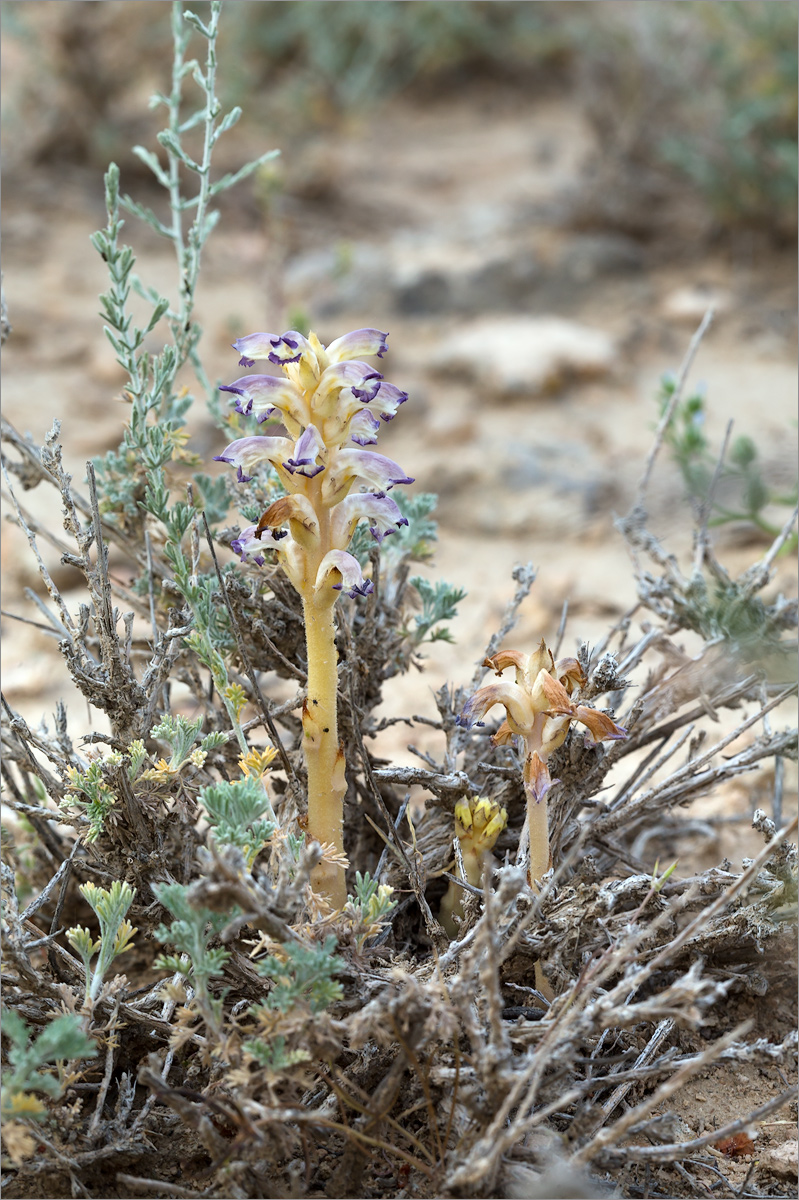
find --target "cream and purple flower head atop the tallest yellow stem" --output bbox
[217,329,413,605]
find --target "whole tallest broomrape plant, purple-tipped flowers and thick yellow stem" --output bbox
[217,329,413,907]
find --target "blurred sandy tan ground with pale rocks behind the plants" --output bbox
[2,88,797,1194]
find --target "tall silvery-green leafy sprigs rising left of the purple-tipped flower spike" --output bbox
[92,0,277,532]
